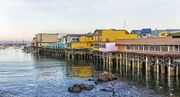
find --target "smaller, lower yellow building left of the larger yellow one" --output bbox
[71,35,92,49]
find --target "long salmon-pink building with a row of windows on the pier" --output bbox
[116,37,180,54]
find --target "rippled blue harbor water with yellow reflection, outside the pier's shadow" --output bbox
[0,47,179,97]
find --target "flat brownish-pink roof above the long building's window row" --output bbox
[116,37,180,45]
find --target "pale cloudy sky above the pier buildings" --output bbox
[0,0,180,40]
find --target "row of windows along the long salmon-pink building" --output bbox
[127,45,180,51]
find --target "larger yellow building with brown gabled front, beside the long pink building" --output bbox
[92,29,137,50]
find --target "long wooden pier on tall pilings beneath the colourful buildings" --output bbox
[29,47,180,79]
